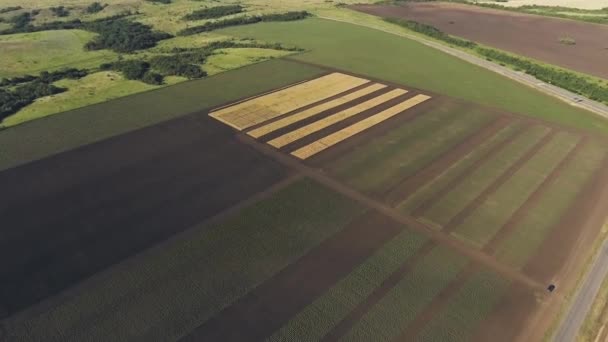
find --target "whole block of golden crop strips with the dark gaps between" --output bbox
[209,72,431,159]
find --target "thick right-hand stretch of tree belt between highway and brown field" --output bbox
[477,48,608,103]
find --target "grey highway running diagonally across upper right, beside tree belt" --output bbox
[319,16,608,118]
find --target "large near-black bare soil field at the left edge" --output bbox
[0,114,285,313]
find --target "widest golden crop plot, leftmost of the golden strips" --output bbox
[209,72,369,130]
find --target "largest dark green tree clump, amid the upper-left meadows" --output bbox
[84,19,172,52]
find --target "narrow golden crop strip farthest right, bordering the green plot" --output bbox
[291,95,431,159]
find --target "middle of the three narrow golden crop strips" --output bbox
[268,89,407,148]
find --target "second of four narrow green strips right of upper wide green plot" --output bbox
[423,126,548,228]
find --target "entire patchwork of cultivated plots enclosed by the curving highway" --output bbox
[0,0,608,342]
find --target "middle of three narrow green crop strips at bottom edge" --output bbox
[342,247,467,342]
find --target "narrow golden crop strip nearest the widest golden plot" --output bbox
[247,83,386,138]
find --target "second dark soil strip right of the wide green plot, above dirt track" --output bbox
[412,121,529,217]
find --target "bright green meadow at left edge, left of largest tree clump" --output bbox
[0,30,117,77]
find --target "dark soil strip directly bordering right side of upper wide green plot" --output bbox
[385,116,513,205]
